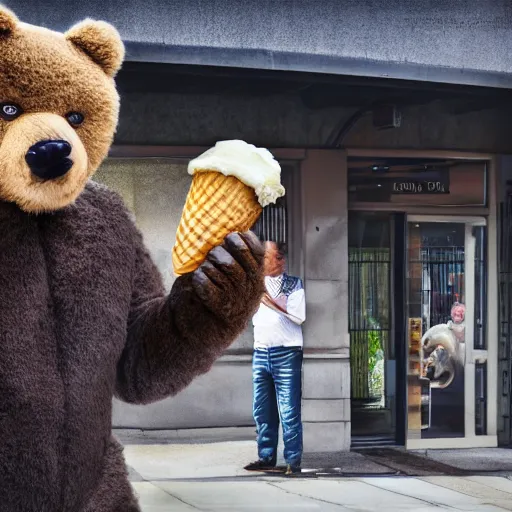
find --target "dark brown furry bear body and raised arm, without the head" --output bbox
[0,184,263,512]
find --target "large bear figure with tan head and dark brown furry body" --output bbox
[0,7,263,512]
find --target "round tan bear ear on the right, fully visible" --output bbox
[64,20,124,77]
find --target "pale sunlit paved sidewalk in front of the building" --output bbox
[125,441,512,512]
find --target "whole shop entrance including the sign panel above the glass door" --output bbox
[348,151,495,449]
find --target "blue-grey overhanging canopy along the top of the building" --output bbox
[8,0,512,88]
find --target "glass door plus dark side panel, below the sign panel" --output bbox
[349,212,487,446]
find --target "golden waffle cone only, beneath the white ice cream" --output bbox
[172,171,262,275]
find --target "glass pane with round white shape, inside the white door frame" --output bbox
[408,223,466,438]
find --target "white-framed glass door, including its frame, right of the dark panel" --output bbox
[405,216,486,448]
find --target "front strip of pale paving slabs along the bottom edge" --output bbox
[133,477,512,512]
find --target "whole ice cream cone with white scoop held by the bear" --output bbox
[172,140,285,275]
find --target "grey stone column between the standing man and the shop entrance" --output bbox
[301,150,350,453]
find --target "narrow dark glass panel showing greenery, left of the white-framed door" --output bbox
[348,212,396,446]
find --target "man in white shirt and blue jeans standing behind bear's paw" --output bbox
[245,242,306,475]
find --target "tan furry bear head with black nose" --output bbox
[0,6,124,213]
